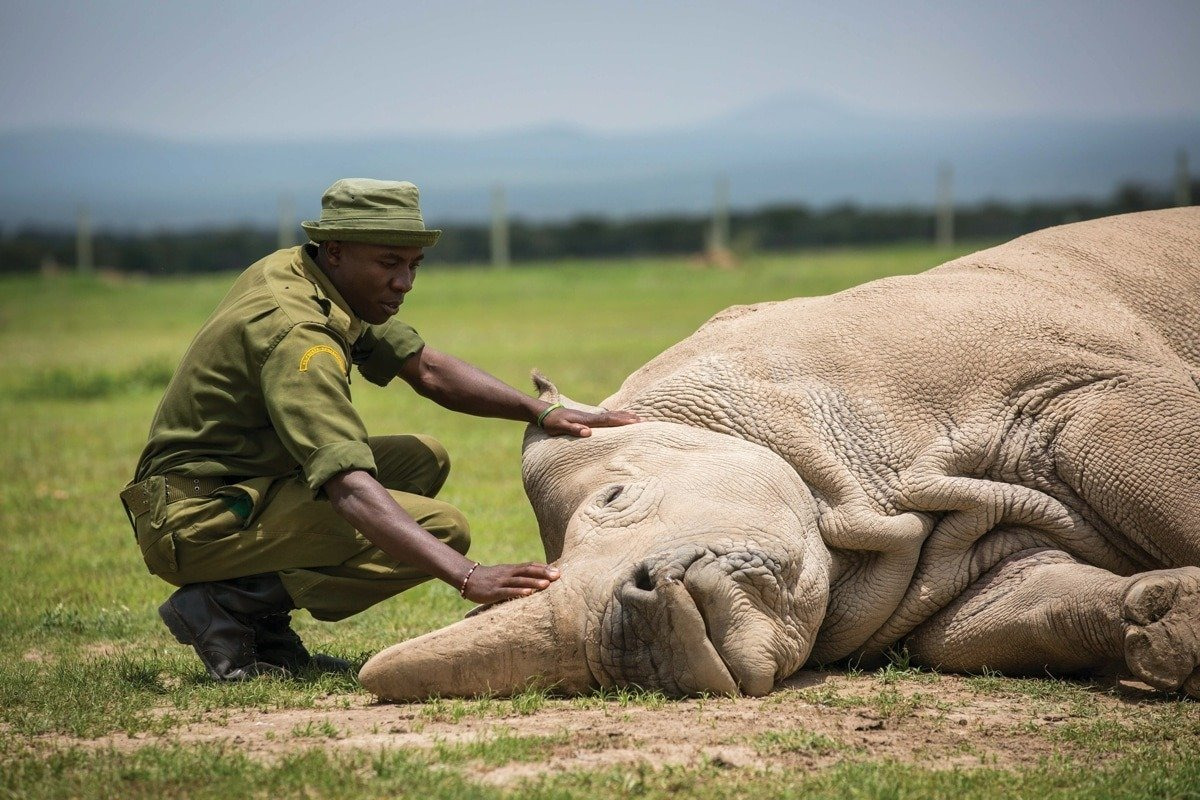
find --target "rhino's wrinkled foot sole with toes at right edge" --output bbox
[1122,567,1200,698]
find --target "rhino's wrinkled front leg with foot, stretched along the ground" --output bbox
[906,549,1200,697]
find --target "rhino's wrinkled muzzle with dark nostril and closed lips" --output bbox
[587,547,786,696]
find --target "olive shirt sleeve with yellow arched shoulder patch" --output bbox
[262,323,376,493]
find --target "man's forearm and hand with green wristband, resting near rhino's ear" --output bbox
[400,345,638,437]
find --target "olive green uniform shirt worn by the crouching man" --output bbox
[134,247,425,492]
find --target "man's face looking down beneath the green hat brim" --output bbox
[324,241,425,325]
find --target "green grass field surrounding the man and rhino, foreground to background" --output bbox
[0,246,1200,798]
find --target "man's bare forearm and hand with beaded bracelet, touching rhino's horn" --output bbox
[323,469,559,603]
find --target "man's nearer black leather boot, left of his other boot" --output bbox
[158,573,295,680]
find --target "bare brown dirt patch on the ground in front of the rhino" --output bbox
[30,672,1200,783]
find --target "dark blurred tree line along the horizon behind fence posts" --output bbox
[0,181,1200,275]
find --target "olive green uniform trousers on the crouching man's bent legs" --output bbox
[134,435,470,620]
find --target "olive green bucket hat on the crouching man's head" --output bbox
[300,178,442,247]
